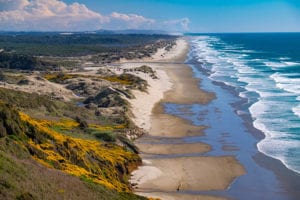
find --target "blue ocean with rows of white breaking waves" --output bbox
[191,33,300,173]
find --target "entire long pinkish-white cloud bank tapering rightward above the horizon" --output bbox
[0,0,189,31]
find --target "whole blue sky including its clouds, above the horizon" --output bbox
[0,0,300,32]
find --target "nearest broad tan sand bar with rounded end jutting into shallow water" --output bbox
[133,155,244,192]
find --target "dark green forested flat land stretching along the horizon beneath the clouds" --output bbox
[0,33,174,56]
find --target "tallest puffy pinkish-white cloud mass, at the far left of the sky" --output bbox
[0,0,109,31]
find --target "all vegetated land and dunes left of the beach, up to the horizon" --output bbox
[0,33,176,200]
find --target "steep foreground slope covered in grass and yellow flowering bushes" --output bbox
[0,99,144,199]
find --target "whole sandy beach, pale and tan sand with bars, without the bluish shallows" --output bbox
[121,39,245,199]
